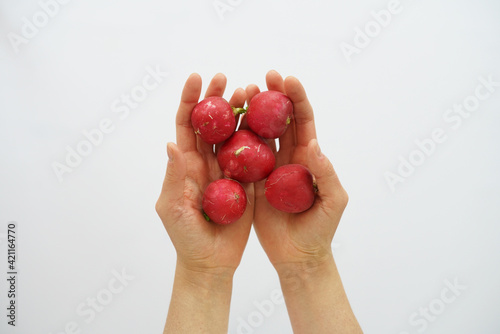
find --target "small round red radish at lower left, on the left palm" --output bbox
[202,179,247,225]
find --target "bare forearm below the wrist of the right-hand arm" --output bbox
[276,256,362,334]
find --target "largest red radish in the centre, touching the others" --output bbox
[217,130,276,182]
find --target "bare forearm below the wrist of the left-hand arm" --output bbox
[164,263,233,334]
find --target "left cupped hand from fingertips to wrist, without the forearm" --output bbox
[156,74,254,275]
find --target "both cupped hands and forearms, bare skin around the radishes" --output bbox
[156,71,362,334]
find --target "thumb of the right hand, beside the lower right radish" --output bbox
[307,139,348,210]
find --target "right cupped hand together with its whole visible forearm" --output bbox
[246,71,362,334]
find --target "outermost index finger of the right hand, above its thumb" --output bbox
[285,77,316,146]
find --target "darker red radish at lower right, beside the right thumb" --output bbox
[265,164,317,213]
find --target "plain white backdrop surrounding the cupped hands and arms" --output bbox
[0,0,500,334]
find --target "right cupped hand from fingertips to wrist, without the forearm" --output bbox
[246,71,348,272]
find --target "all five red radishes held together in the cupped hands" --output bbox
[191,91,316,224]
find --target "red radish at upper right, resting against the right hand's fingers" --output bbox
[246,90,293,138]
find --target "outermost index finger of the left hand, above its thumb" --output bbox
[175,73,201,152]
